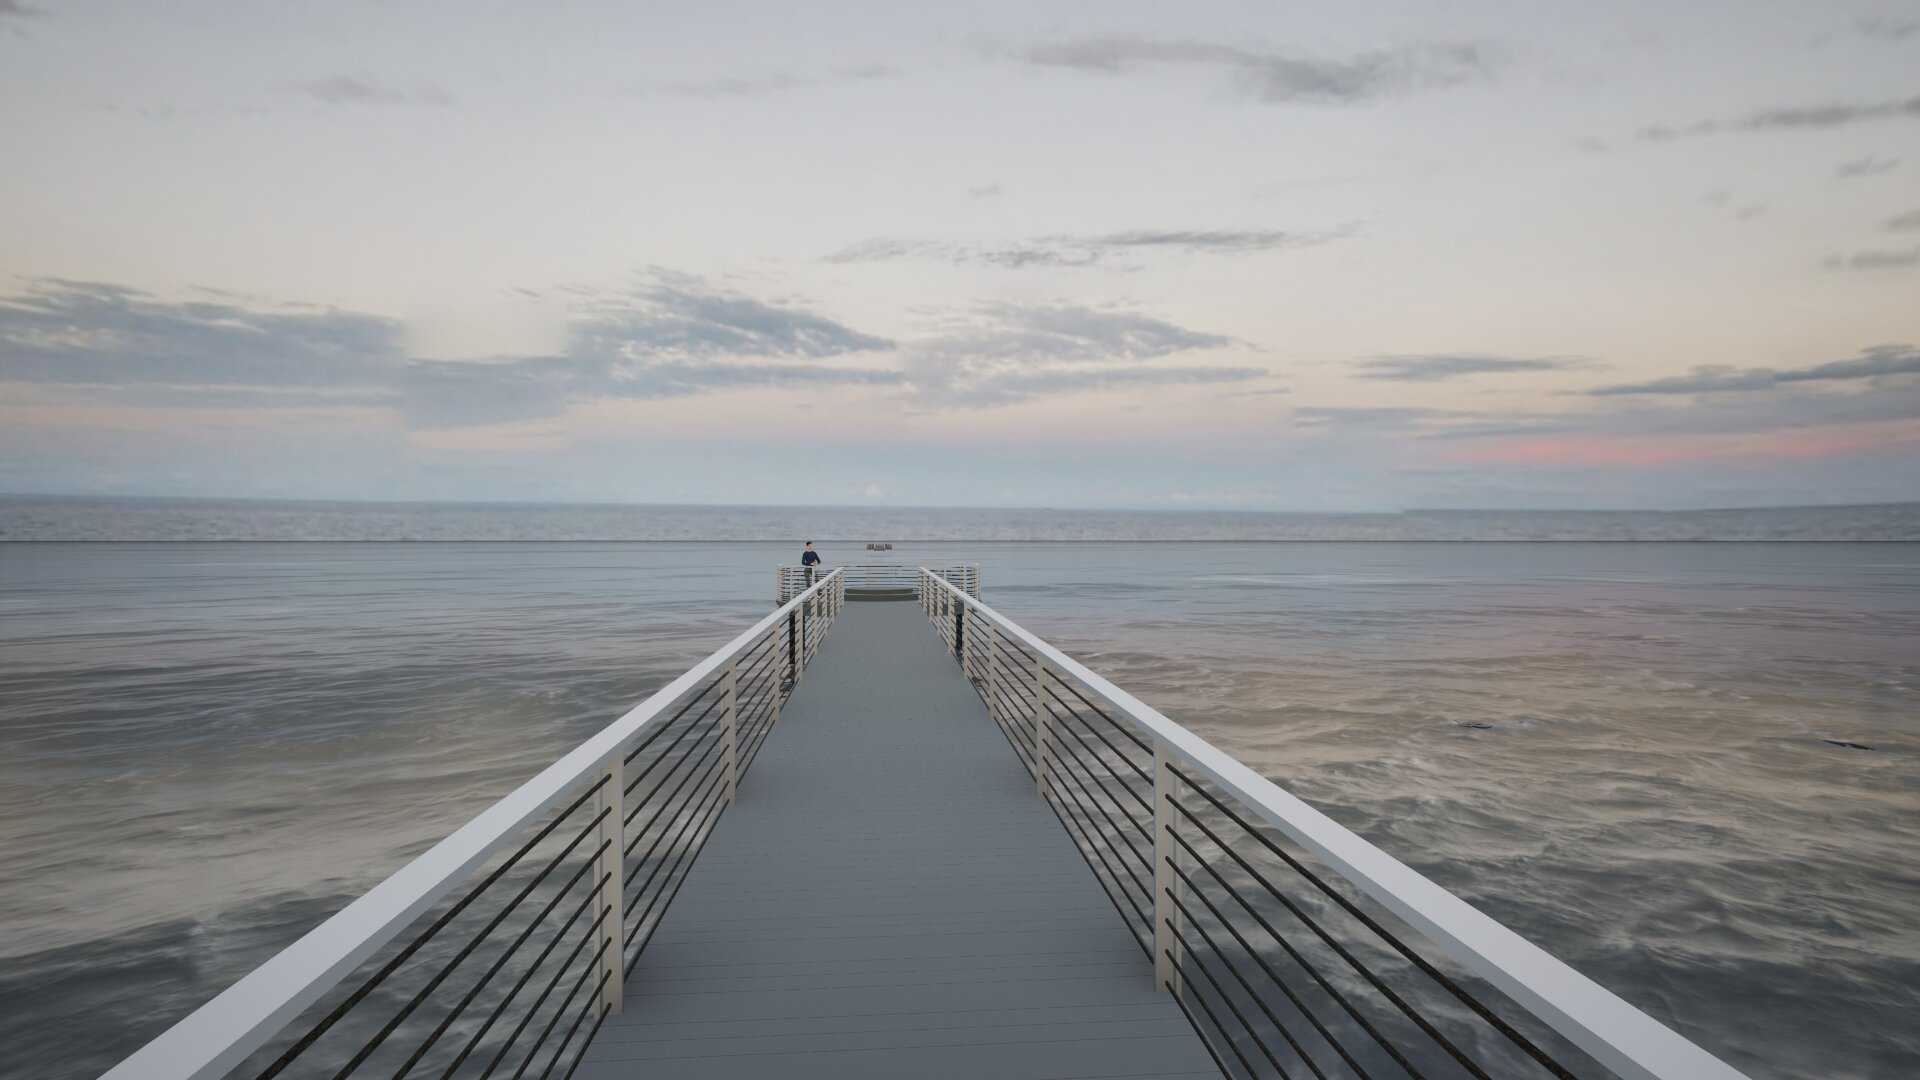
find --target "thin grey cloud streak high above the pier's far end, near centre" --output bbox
[824,225,1357,269]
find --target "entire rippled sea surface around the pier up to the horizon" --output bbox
[0,500,1920,1080]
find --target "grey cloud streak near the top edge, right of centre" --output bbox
[991,35,1488,104]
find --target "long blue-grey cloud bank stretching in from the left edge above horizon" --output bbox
[0,275,902,427]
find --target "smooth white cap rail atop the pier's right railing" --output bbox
[922,567,1747,1080]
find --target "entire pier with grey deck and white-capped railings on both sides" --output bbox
[108,567,1741,1080]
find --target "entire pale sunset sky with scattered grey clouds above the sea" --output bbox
[0,0,1920,511]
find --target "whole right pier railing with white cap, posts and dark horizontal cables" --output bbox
[920,569,1741,1080]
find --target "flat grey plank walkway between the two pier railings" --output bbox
[576,603,1219,1080]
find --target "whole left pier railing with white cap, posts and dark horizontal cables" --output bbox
[106,573,845,1080]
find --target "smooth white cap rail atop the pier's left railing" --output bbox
[102,571,839,1080]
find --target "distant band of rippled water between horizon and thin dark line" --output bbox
[11,496,1920,544]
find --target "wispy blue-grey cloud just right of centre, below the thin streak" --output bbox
[902,304,1269,407]
